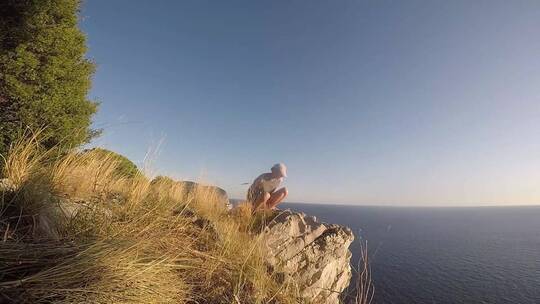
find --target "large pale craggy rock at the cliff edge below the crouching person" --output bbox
[262,210,354,304]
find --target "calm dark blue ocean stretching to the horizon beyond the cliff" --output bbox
[280,203,540,304]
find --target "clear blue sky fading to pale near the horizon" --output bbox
[81,0,540,206]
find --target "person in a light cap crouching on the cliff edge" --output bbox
[247,163,288,211]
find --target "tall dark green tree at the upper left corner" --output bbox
[0,0,99,155]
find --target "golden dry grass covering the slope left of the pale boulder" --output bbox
[0,136,299,303]
